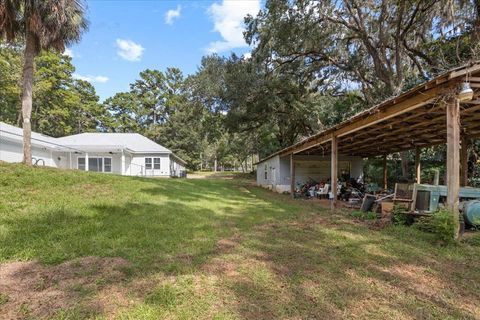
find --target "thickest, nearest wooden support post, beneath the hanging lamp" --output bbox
[446,97,460,239]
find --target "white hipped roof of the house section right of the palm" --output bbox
[57,133,172,153]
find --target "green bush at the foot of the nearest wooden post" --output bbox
[416,208,455,243]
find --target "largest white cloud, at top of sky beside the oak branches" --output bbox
[207,0,260,53]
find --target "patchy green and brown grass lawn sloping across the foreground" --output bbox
[0,164,480,319]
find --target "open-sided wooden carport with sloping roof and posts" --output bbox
[259,63,480,232]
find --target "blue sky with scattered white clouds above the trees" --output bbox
[66,0,260,100]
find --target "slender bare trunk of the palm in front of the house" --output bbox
[22,31,36,166]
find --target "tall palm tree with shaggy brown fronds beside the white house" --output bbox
[0,0,87,165]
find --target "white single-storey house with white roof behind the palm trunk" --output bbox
[0,122,186,177]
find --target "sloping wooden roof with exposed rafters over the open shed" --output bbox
[257,62,480,164]
